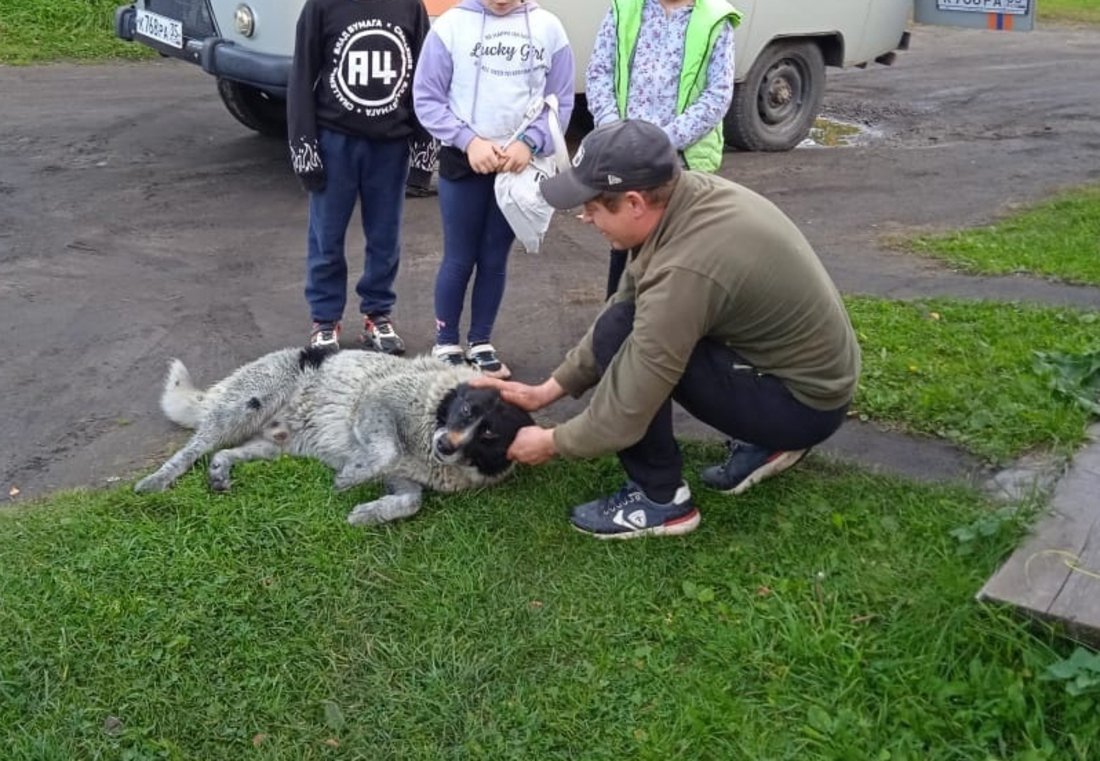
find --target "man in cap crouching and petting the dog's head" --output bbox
[477,120,859,539]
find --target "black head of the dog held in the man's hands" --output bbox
[432,383,535,476]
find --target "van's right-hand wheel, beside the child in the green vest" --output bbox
[723,41,825,151]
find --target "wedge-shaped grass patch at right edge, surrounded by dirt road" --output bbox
[904,185,1100,285]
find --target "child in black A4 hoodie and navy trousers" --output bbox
[287,0,430,354]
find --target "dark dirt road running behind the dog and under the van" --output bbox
[0,26,1100,504]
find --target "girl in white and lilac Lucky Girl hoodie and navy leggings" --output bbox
[413,0,574,378]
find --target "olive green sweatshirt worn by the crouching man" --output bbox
[553,172,859,457]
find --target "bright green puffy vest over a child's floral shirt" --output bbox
[612,0,741,172]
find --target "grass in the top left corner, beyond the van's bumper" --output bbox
[0,0,155,64]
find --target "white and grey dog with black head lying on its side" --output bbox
[134,349,534,525]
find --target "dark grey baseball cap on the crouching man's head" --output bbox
[539,119,680,209]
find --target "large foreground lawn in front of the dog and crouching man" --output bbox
[0,446,1100,761]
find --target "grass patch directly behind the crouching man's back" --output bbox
[846,297,1100,463]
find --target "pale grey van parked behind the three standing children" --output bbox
[114,0,912,151]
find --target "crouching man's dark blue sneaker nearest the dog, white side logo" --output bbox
[570,481,700,539]
